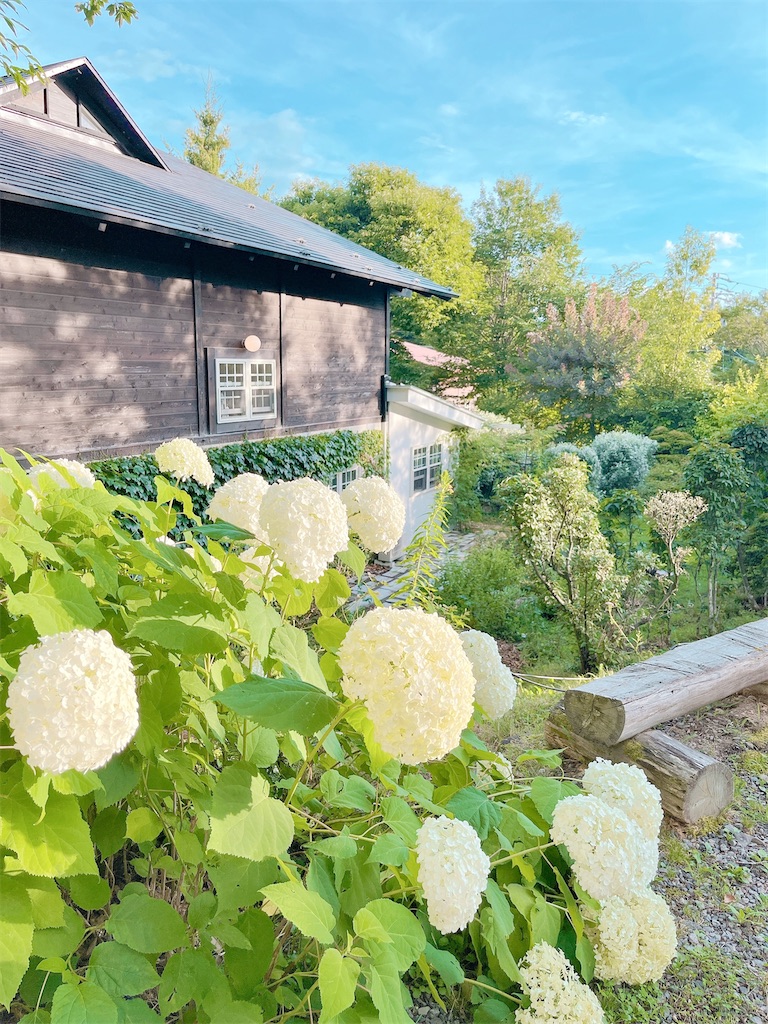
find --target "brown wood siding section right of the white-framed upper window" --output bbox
[283,290,386,429]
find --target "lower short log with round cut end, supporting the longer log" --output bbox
[545,702,733,824]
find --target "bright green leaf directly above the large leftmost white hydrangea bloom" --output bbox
[7,569,103,637]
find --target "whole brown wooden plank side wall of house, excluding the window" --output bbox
[0,202,386,458]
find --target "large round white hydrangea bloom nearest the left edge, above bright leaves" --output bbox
[8,630,138,774]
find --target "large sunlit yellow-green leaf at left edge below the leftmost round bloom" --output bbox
[0,773,98,878]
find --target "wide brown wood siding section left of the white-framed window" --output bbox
[0,251,198,456]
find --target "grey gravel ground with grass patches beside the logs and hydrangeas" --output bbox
[411,695,768,1024]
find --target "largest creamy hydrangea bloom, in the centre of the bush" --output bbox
[339,608,475,765]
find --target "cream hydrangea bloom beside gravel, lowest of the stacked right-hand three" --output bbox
[590,889,677,985]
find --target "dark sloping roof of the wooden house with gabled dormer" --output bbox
[0,57,456,299]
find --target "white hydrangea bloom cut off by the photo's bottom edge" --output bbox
[515,942,605,1024]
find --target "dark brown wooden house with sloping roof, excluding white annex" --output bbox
[0,58,481,548]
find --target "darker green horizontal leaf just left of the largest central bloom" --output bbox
[213,676,339,736]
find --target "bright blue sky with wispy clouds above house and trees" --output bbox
[13,0,768,290]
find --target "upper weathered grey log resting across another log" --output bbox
[565,647,768,746]
